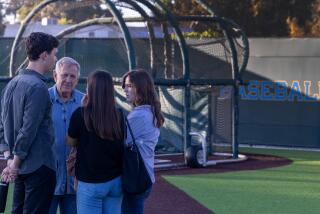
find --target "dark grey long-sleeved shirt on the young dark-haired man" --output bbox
[0,69,55,174]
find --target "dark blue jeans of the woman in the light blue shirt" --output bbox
[122,186,152,214]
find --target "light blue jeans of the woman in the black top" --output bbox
[77,176,123,214]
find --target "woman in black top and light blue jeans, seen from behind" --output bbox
[68,71,124,214]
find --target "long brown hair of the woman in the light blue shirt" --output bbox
[122,69,164,128]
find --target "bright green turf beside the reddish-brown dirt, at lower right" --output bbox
[165,149,320,214]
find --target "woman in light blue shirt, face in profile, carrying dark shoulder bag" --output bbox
[122,70,164,214]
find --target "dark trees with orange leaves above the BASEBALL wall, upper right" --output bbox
[164,0,320,37]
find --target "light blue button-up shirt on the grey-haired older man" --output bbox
[49,86,84,195]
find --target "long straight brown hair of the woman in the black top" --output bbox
[83,70,123,140]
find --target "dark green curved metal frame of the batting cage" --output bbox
[6,0,249,158]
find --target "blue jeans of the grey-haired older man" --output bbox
[49,194,77,214]
